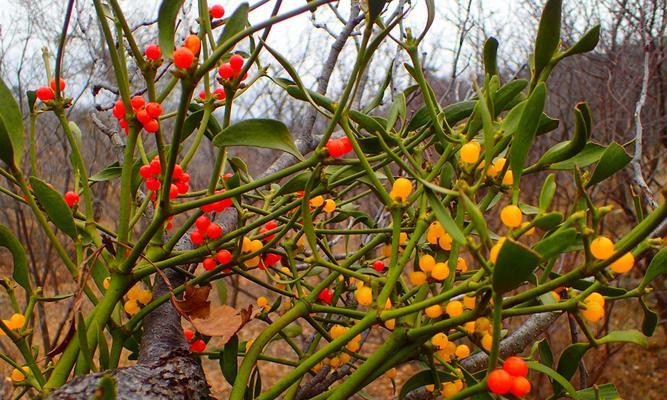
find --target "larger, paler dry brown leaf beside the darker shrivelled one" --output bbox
[192,304,256,344]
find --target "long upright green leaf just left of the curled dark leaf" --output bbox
[509,83,546,187]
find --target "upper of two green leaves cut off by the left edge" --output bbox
[0,79,24,165]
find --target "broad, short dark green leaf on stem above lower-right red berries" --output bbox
[493,239,540,294]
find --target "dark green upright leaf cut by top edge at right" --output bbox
[534,0,562,77]
